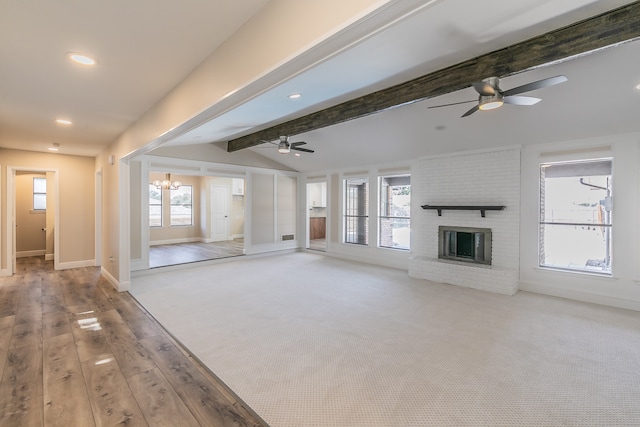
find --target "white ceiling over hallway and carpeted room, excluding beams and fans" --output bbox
[0,0,640,171]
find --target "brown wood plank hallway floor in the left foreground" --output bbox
[0,257,266,427]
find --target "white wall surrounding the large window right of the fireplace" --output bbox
[520,134,640,310]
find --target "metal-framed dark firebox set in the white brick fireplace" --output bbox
[438,226,491,265]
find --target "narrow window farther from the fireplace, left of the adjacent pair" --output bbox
[344,178,369,245]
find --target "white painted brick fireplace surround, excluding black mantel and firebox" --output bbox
[409,149,520,295]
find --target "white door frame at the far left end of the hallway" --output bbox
[5,166,60,276]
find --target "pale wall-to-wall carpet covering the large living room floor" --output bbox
[132,253,640,427]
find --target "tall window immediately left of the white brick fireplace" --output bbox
[378,175,411,250]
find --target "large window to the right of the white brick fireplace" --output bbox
[539,159,612,274]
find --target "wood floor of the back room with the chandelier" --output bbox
[149,239,244,268]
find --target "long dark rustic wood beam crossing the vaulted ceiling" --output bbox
[227,1,640,152]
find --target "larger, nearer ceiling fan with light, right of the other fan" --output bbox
[429,75,567,117]
